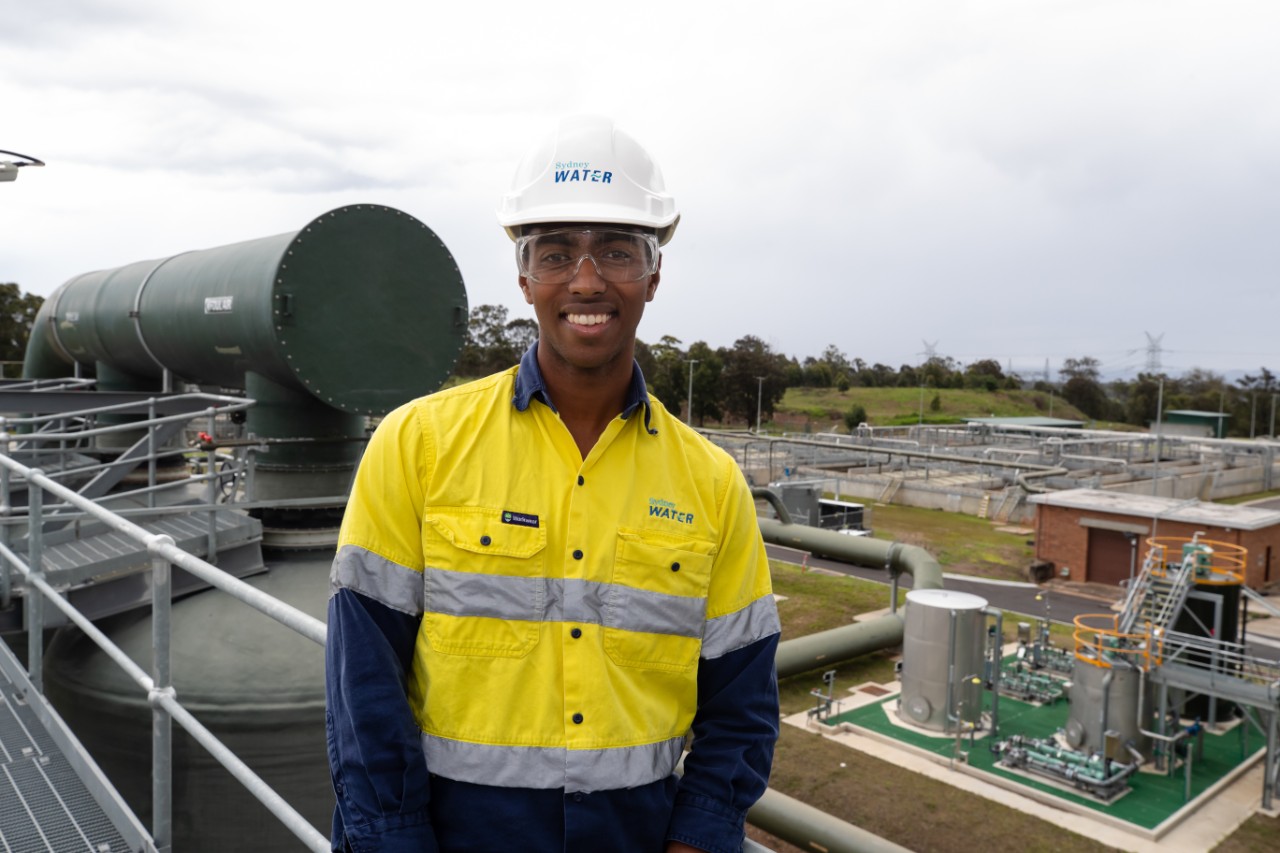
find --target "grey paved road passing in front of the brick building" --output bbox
[765,544,1280,660]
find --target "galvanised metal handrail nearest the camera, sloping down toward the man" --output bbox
[0,452,329,853]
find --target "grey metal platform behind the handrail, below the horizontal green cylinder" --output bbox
[0,507,266,634]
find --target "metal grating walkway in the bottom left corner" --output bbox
[0,642,155,853]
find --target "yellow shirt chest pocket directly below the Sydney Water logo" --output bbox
[603,529,716,672]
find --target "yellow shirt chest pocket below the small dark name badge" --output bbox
[422,507,547,657]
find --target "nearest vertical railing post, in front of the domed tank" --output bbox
[147,535,174,850]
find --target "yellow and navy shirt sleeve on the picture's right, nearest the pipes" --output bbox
[667,465,778,853]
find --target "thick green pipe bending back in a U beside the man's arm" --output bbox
[756,512,942,679]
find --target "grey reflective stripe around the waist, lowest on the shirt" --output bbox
[422,734,685,793]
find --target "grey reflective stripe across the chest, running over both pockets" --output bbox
[425,569,707,637]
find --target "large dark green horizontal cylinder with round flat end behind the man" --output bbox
[24,199,467,415]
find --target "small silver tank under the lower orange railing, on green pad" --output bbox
[1064,660,1152,756]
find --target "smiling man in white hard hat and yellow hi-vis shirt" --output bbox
[326,118,778,853]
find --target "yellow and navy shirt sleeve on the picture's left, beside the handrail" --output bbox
[325,410,438,853]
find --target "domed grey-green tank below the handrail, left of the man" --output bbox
[45,551,334,852]
